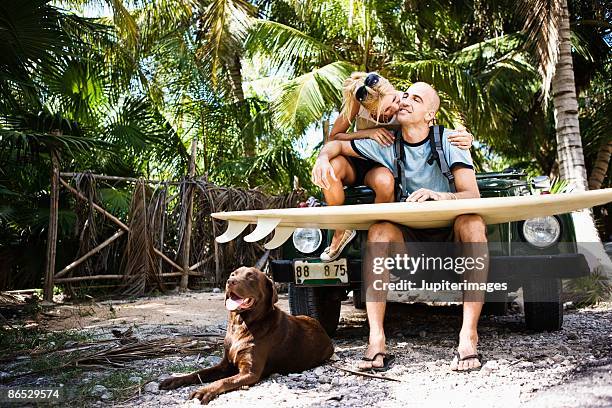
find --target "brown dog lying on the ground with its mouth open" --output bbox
[159,267,334,404]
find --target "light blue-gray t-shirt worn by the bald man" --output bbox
[351,129,474,194]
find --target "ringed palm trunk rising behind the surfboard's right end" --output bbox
[551,0,612,277]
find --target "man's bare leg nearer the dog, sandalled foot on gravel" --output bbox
[359,222,404,370]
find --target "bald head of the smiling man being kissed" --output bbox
[397,82,440,126]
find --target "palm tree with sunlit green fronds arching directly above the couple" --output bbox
[245,0,537,143]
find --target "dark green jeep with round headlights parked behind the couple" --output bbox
[270,170,589,335]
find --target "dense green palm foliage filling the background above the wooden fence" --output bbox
[0,0,612,292]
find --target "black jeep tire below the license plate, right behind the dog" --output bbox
[289,283,344,337]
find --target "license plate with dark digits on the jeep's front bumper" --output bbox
[293,258,348,285]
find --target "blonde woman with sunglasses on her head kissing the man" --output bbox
[321,72,473,262]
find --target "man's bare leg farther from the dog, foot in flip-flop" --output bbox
[451,215,489,371]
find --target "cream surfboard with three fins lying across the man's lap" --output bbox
[211,188,612,249]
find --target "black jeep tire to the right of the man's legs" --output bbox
[523,279,563,331]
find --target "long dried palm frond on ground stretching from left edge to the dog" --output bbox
[2,333,222,383]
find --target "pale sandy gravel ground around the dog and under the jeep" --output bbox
[9,292,612,408]
